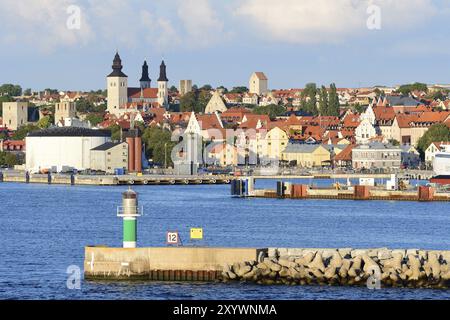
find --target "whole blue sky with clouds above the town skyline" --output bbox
[0,0,450,90]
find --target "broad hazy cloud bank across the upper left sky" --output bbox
[0,0,224,52]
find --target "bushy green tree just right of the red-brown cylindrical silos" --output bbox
[142,127,177,166]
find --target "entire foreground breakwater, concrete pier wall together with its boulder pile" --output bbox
[84,247,450,288]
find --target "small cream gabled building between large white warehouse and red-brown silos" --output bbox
[89,142,128,173]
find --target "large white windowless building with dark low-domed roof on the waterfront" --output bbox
[26,127,111,172]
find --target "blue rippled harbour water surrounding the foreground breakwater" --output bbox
[0,181,450,299]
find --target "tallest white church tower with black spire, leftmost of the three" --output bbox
[107,52,128,115]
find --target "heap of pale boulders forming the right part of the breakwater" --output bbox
[222,248,450,288]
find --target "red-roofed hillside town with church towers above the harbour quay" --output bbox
[0,53,450,174]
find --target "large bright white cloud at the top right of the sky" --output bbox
[234,0,437,43]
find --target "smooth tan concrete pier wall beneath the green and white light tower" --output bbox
[84,247,267,280]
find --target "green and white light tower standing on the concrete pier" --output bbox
[117,188,143,248]
